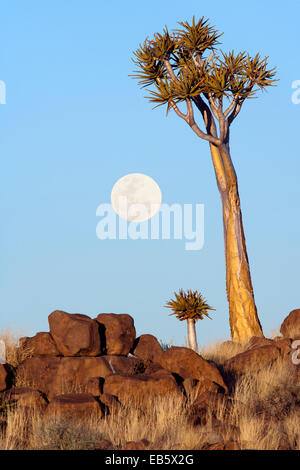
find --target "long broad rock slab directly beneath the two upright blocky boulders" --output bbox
[17,356,144,397]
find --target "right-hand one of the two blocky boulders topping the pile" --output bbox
[96,313,136,356]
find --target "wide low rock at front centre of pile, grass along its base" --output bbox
[103,374,181,406]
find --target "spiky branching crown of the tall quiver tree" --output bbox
[131,17,277,145]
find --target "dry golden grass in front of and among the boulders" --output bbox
[0,332,300,450]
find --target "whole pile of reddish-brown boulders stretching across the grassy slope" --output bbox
[0,309,300,448]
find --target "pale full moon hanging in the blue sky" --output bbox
[111,173,162,223]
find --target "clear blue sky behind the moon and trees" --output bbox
[0,0,300,345]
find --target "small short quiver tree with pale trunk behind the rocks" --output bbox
[165,289,215,352]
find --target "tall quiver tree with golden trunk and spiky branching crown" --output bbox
[132,17,276,343]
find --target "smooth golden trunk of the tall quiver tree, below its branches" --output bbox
[210,144,263,343]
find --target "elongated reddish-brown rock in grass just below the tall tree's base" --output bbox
[223,345,280,374]
